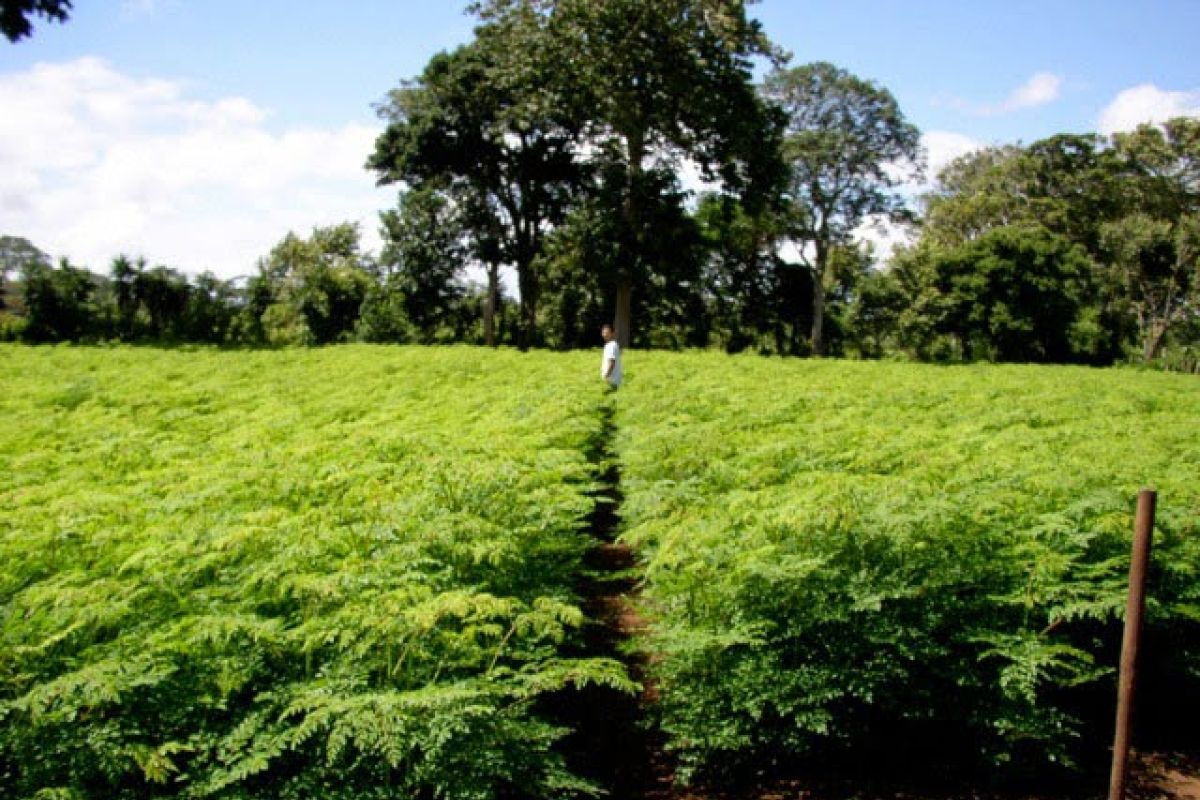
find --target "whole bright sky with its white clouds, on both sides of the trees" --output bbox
[0,0,1200,278]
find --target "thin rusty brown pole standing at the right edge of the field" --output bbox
[1109,489,1158,800]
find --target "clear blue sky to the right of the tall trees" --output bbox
[754,0,1200,142]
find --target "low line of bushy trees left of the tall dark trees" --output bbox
[0,226,515,347]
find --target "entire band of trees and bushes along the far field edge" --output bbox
[0,0,1200,371]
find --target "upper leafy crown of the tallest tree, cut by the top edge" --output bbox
[496,0,781,185]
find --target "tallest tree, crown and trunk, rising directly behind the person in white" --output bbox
[475,0,778,345]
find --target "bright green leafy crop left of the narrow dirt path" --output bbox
[0,348,629,799]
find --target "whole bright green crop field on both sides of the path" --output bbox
[0,345,1200,799]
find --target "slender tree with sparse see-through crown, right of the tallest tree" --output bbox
[763,62,922,355]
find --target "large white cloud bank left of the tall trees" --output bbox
[0,59,395,277]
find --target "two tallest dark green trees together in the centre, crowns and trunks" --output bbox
[381,0,778,343]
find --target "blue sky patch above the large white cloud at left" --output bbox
[0,0,474,127]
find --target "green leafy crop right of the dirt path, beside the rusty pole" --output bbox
[617,354,1200,777]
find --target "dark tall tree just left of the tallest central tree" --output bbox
[368,29,578,347]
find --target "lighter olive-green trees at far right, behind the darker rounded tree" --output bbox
[900,118,1200,368]
